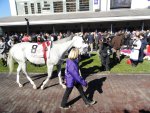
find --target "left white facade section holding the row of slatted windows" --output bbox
[10,0,93,16]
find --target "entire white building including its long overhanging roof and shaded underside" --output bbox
[0,0,150,33]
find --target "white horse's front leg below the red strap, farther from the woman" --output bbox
[41,65,54,90]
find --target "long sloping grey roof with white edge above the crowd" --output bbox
[0,9,150,26]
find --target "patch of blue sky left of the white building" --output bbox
[0,0,11,18]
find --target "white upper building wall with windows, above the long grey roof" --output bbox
[9,0,150,16]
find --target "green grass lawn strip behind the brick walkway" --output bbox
[0,52,150,74]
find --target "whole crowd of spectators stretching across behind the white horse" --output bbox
[0,30,150,68]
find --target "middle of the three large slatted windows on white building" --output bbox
[66,0,76,12]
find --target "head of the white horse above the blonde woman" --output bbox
[73,36,87,53]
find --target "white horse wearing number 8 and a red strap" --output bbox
[8,36,84,89]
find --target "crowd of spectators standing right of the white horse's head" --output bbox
[83,30,150,71]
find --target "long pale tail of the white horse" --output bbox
[7,51,14,75]
